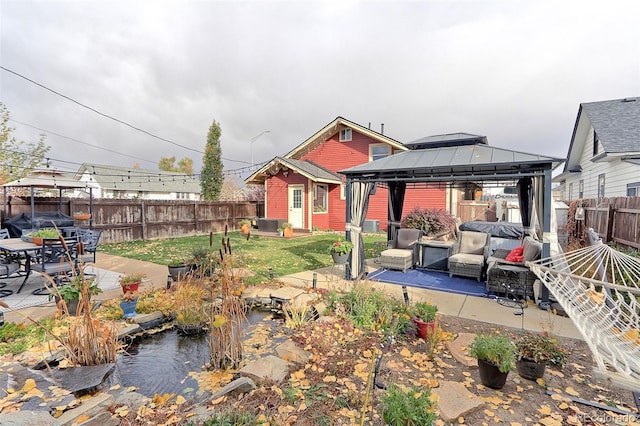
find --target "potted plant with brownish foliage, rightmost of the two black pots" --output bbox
[515,332,567,380]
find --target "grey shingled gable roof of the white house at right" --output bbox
[563,97,640,173]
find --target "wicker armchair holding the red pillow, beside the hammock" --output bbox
[487,237,542,299]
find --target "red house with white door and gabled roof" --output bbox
[245,117,448,230]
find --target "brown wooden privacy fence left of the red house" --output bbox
[0,197,257,243]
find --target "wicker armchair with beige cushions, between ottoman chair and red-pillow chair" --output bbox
[448,231,491,281]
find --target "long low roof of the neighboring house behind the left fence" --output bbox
[76,163,201,194]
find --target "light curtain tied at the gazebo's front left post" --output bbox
[348,182,375,279]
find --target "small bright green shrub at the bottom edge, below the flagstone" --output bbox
[380,384,436,426]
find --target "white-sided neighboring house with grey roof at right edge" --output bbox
[553,98,640,201]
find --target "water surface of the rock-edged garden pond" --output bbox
[107,310,271,397]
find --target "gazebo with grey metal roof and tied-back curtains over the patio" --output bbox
[340,143,564,309]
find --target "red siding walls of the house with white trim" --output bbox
[267,130,446,230]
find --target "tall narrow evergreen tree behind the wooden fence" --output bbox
[200,120,224,201]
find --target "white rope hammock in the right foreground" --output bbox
[527,230,640,391]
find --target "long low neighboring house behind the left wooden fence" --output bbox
[76,163,200,200]
